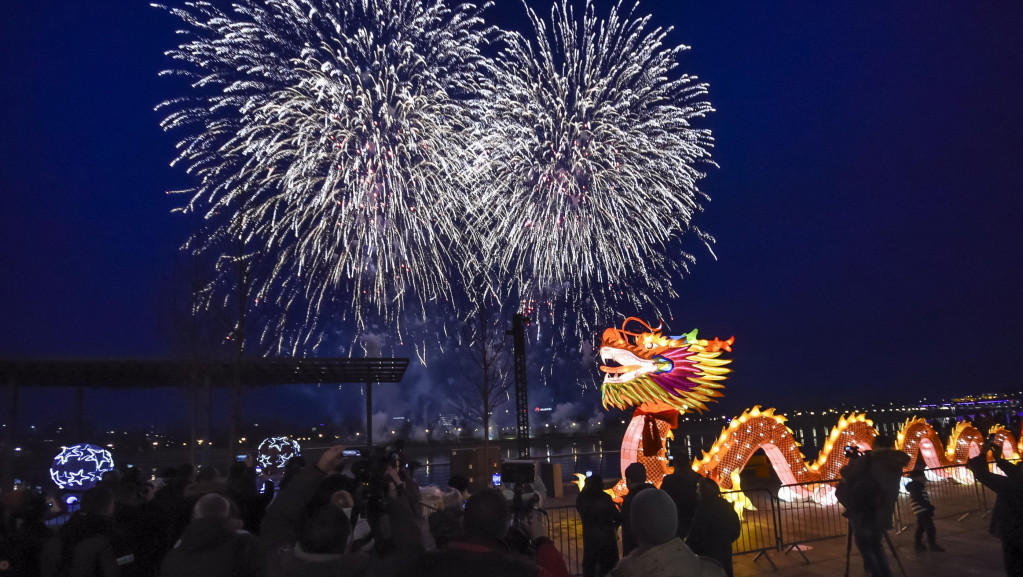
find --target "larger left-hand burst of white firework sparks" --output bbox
[153,0,491,345]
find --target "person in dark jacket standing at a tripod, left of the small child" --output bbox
[837,434,909,577]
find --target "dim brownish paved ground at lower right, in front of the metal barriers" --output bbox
[732,514,1005,577]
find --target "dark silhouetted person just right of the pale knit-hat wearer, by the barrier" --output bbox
[685,477,743,577]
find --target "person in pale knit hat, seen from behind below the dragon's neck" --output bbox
[611,487,725,577]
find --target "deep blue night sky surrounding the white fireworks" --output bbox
[0,0,1023,433]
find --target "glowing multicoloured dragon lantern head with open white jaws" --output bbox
[601,317,736,412]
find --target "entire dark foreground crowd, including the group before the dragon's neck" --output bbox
[0,447,752,577]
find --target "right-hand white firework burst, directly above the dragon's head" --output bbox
[479,0,713,335]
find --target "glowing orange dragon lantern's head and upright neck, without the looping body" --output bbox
[599,317,736,495]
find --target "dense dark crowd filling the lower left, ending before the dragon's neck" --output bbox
[0,447,569,577]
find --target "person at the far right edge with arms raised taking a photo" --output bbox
[967,439,1023,577]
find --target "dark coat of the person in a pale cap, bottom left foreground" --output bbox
[160,519,263,577]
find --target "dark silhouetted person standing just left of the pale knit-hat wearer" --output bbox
[576,475,622,577]
